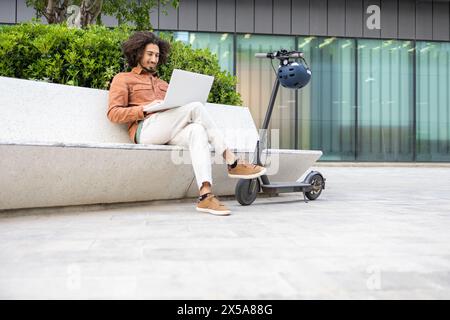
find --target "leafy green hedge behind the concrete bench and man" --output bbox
[0,22,242,105]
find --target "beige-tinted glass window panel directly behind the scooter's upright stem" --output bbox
[236,34,295,149]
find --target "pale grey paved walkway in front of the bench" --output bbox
[0,167,450,299]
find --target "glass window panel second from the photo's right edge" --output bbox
[357,40,413,161]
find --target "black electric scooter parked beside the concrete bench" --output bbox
[235,50,325,206]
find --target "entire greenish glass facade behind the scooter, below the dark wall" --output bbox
[167,32,450,161]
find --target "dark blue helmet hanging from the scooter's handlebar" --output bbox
[278,60,311,89]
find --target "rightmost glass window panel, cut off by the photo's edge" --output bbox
[416,42,450,161]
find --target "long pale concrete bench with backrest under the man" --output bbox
[0,77,322,210]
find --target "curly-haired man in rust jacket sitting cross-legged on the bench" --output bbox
[107,31,266,215]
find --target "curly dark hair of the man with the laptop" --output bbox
[122,31,170,68]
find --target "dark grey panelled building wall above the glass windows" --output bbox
[0,0,450,41]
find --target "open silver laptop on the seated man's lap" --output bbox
[144,69,214,112]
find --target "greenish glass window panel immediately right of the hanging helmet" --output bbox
[298,37,356,160]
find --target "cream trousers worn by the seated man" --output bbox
[138,102,227,189]
